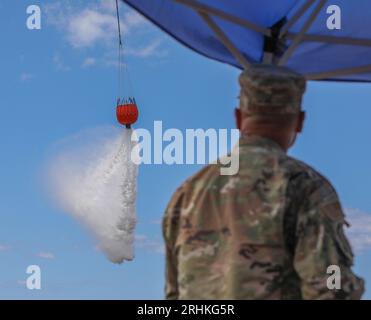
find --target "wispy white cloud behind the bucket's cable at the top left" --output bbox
[44,0,167,65]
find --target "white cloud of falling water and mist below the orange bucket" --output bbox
[48,128,138,263]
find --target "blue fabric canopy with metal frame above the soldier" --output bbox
[123,0,371,81]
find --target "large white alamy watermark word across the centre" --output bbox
[131,121,240,175]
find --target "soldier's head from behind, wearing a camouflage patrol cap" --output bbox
[235,65,306,150]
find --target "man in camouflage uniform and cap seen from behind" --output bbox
[163,66,364,299]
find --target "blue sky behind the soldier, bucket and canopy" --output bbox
[0,0,371,299]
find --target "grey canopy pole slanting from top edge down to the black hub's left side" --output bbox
[173,0,270,36]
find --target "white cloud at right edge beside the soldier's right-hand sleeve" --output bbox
[345,209,371,253]
